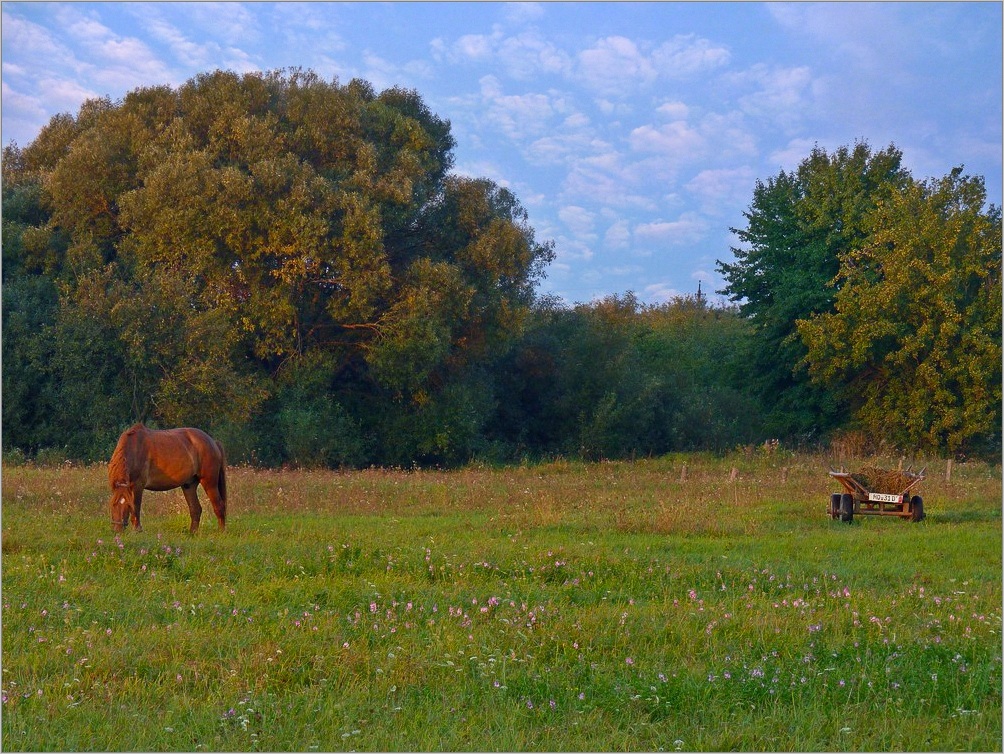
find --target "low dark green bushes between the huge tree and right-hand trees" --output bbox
[490,293,762,459]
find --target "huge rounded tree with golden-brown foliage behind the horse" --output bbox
[4,70,553,461]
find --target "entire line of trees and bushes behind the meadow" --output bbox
[2,69,1001,466]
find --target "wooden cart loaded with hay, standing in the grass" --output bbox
[827,467,927,523]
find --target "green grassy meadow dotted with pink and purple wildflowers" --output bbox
[2,450,1002,751]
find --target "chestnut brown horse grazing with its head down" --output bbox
[108,424,227,533]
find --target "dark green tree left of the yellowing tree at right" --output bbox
[718,143,911,436]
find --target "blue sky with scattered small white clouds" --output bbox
[0,2,1004,304]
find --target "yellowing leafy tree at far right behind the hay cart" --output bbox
[797,168,1002,453]
